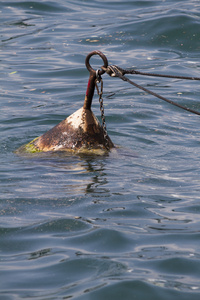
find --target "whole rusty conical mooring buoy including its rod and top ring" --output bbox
[18,50,114,153]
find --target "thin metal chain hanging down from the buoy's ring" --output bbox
[95,70,110,150]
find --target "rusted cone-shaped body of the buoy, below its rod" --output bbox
[33,108,114,152]
